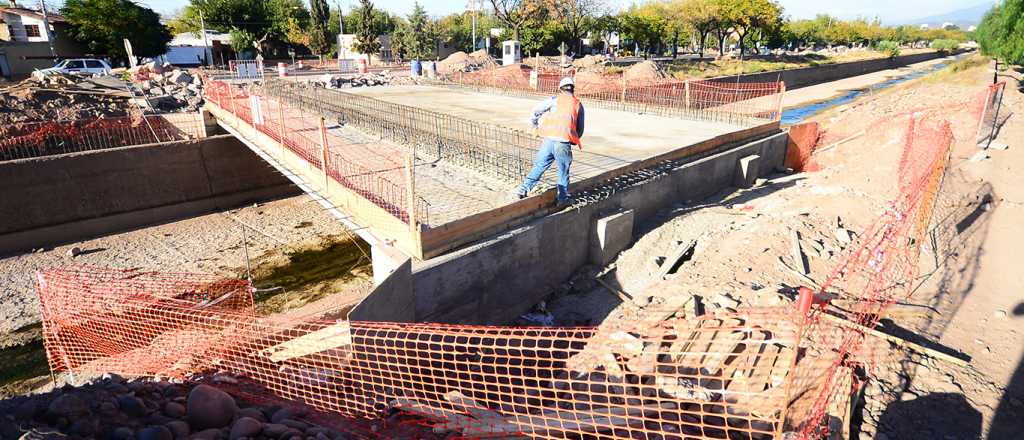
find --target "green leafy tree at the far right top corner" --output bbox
[976,0,1024,64]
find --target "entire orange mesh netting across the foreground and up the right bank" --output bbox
[32,78,977,439]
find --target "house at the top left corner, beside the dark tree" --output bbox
[0,6,84,78]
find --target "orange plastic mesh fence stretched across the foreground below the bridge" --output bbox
[39,268,800,439]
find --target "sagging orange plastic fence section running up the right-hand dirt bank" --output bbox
[788,113,953,439]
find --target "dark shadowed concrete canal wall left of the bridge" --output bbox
[0,136,300,255]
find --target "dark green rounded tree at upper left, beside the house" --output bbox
[60,0,171,59]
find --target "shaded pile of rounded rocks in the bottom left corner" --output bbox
[0,377,349,440]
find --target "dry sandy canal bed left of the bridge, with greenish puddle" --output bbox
[0,196,370,347]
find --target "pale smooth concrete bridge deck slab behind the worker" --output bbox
[350,86,748,180]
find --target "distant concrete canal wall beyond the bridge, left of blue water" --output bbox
[708,52,947,90]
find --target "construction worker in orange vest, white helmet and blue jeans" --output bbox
[516,78,584,205]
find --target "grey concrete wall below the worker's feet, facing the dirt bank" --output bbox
[413,133,788,323]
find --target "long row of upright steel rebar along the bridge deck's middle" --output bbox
[263,81,540,182]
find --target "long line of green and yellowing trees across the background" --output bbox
[153,0,974,63]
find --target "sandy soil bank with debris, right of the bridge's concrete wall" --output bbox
[546,60,1024,439]
